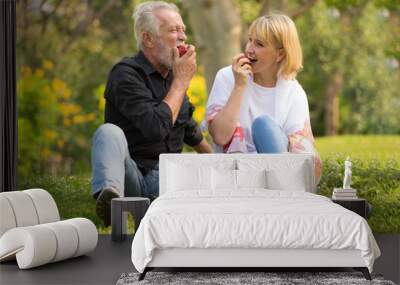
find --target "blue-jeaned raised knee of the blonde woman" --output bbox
[251,116,289,153]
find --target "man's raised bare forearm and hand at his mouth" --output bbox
[163,45,197,124]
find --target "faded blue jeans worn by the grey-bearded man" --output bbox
[92,123,159,200]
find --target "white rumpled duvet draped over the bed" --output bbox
[132,189,380,272]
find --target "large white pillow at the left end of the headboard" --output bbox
[167,162,211,191]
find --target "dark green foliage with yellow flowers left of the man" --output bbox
[16,0,136,175]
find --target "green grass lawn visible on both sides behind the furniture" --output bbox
[19,136,400,233]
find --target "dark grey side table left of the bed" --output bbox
[111,197,150,241]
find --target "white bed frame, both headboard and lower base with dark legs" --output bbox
[139,154,371,280]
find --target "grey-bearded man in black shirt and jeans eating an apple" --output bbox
[92,1,212,226]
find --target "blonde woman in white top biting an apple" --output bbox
[206,14,322,182]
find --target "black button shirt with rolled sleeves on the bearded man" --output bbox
[104,52,203,174]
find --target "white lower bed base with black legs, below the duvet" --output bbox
[139,248,371,281]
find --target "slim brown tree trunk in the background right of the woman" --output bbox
[325,72,343,136]
